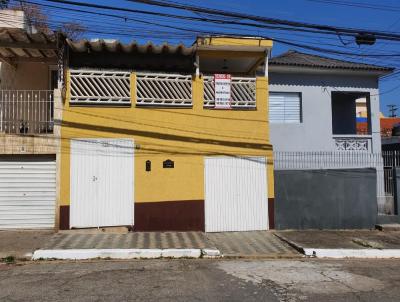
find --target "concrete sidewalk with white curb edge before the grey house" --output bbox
[276,230,400,258]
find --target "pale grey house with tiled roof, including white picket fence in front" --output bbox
[269,51,395,214]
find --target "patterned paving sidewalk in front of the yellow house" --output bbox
[41,231,300,258]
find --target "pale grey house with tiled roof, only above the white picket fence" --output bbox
[269,51,393,152]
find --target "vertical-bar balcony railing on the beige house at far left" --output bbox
[0,90,54,134]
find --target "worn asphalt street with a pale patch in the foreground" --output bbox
[0,259,400,302]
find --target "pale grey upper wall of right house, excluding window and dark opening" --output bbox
[269,71,381,152]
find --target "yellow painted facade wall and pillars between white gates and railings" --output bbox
[60,74,274,205]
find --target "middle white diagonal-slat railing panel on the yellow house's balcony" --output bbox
[136,73,193,107]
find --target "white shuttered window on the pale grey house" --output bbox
[269,92,302,124]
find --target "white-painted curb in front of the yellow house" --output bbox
[32,249,221,260]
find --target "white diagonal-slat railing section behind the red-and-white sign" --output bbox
[204,76,256,109]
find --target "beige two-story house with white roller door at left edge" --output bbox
[0,10,61,229]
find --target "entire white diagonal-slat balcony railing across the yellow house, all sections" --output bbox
[69,69,256,109]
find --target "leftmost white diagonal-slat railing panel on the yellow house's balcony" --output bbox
[70,69,131,105]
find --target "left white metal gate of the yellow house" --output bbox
[70,139,134,228]
